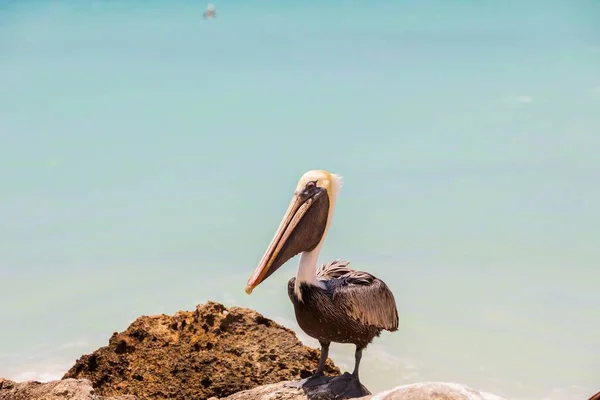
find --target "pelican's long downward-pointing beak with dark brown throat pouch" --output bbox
[246,187,329,294]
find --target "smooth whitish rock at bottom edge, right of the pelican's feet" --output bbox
[364,382,506,400]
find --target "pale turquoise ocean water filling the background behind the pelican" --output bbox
[0,0,600,400]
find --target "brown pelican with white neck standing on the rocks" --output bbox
[246,170,398,387]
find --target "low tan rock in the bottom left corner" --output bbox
[0,378,137,400]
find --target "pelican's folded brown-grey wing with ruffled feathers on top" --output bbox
[317,260,398,332]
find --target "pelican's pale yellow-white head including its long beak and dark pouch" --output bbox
[246,170,342,294]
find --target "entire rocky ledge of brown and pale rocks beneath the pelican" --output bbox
[0,302,524,400]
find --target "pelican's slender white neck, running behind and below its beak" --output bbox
[294,174,343,301]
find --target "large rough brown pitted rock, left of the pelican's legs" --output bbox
[63,302,340,400]
